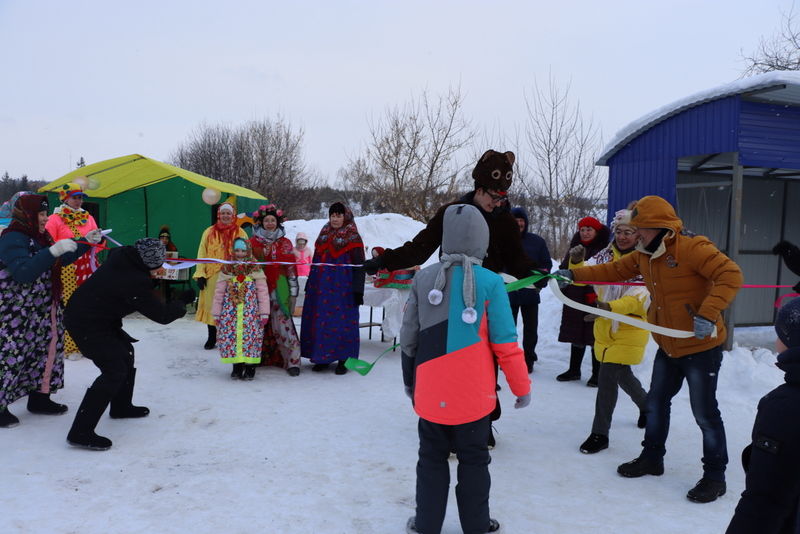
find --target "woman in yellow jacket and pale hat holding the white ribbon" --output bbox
[580,206,650,454]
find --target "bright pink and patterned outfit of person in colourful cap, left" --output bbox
[45,204,98,354]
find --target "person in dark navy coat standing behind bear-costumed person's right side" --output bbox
[508,207,552,373]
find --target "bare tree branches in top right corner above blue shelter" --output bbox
[742,6,800,76]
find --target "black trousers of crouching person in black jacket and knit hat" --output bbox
[68,328,134,402]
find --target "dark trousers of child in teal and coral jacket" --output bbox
[416,416,491,534]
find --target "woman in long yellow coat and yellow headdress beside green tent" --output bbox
[194,199,247,350]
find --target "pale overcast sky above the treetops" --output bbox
[0,0,792,184]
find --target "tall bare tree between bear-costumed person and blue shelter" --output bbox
[512,77,607,258]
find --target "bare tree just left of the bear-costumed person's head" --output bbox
[339,89,473,221]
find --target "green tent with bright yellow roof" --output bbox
[39,154,266,258]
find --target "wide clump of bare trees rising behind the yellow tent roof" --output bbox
[171,117,321,217]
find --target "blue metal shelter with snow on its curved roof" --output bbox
[597,72,800,325]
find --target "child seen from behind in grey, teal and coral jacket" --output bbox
[400,204,530,534]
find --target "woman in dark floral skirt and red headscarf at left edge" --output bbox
[0,193,101,428]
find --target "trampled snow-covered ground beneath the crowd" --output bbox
[0,216,782,534]
